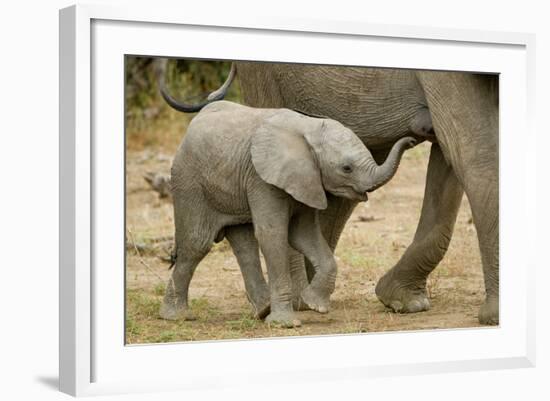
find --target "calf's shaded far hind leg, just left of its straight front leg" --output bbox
[225,224,269,319]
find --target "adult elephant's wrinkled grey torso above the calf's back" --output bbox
[237,63,426,149]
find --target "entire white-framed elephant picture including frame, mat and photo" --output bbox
[60,6,535,395]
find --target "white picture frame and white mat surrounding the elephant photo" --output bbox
[59,5,536,396]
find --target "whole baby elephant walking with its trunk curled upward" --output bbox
[161,101,415,327]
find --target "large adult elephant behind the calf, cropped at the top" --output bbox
[161,62,499,324]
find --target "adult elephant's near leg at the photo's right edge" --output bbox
[418,71,499,324]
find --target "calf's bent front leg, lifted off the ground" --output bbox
[289,209,337,313]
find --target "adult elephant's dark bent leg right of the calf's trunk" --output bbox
[376,144,463,313]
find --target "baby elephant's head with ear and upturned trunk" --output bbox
[251,110,416,209]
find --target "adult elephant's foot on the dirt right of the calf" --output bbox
[375,270,430,313]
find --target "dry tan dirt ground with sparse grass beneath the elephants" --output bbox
[126,133,484,344]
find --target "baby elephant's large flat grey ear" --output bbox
[250,121,327,209]
